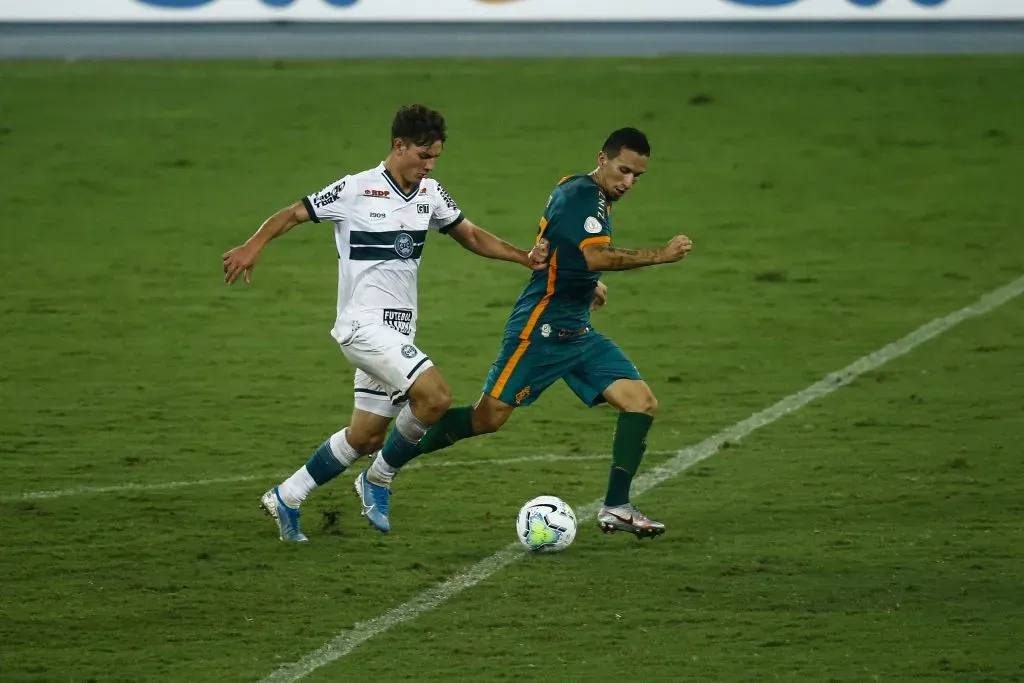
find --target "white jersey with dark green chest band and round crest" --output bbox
[302,163,463,343]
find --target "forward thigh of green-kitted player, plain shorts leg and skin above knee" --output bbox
[565,332,650,412]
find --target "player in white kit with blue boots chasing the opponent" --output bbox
[223,104,548,541]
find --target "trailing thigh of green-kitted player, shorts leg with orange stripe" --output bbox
[483,337,570,407]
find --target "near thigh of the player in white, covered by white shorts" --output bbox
[339,325,433,395]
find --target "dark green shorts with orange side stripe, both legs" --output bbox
[483,331,641,407]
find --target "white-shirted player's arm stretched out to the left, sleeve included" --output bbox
[221,178,345,285]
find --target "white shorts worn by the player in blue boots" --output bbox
[339,324,434,418]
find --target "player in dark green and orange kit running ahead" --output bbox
[364,128,692,538]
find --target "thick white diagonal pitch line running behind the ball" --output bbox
[262,276,1024,683]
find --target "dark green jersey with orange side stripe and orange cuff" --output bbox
[506,175,611,340]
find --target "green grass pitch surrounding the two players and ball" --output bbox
[0,57,1024,683]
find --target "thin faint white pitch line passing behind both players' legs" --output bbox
[0,451,638,503]
